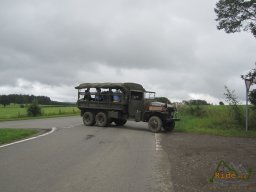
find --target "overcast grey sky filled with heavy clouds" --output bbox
[0,0,256,103]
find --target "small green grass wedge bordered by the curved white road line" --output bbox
[0,128,39,145]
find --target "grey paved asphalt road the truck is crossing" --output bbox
[0,117,173,192]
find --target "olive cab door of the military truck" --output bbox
[128,91,144,121]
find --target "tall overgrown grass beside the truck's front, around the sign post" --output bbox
[175,106,256,137]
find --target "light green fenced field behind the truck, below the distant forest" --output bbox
[0,104,80,121]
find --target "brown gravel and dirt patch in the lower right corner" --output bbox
[161,132,256,192]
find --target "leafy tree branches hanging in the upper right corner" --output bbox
[214,0,256,38]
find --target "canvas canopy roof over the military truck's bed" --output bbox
[75,83,145,92]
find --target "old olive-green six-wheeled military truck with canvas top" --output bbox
[75,83,179,133]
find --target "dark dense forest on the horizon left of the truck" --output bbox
[0,94,71,107]
